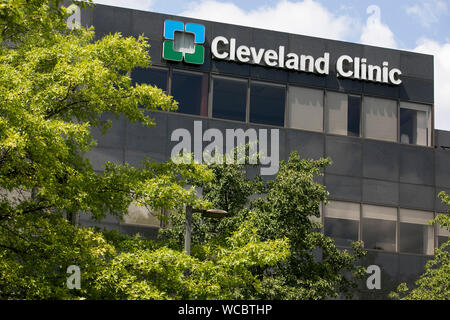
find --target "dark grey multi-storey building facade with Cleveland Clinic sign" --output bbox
[77,5,450,298]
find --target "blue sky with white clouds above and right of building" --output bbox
[94,0,450,130]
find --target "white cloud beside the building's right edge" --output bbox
[413,39,450,130]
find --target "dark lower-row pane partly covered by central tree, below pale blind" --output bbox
[324,218,359,247]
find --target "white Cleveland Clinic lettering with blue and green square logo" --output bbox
[162,20,402,85]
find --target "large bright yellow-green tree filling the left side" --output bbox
[0,0,289,299]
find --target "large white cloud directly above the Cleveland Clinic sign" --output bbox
[180,0,358,40]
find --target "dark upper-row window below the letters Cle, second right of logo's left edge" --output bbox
[211,77,248,122]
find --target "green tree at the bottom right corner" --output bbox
[390,192,450,300]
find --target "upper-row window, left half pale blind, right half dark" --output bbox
[326,92,361,137]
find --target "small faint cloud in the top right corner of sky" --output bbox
[406,0,448,28]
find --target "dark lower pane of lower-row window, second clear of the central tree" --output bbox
[362,218,396,251]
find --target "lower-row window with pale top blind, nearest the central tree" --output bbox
[324,201,360,247]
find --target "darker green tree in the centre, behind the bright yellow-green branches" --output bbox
[160,152,365,299]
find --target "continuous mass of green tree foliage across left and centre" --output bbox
[0,0,361,299]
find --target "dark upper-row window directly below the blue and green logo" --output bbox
[171,71,208,116]
